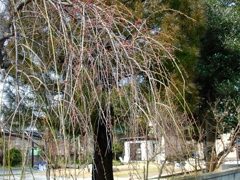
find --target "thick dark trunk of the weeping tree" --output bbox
[92,118,113,180]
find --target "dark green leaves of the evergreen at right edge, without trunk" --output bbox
[198,0,240,129]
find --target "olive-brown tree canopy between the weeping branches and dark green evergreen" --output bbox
[122,0,206,112]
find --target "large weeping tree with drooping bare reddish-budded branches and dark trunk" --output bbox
[0,0,202,180]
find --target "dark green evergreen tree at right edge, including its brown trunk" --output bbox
[197,0,240,171]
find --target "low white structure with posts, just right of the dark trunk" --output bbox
[120,136,204,164]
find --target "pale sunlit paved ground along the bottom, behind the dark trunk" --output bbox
[0,163,204,180]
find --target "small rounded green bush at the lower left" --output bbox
[5,148,22,166]
